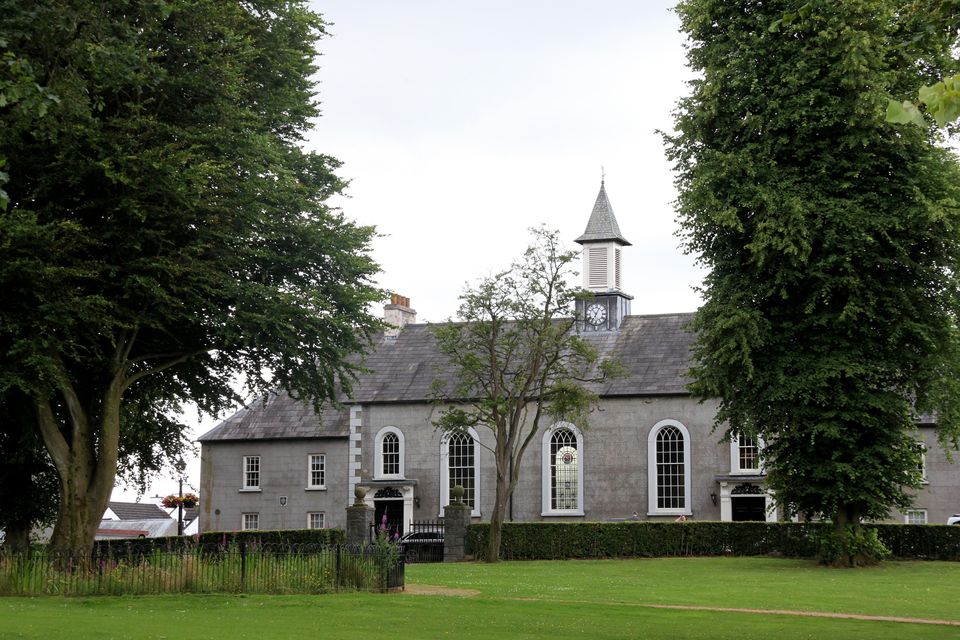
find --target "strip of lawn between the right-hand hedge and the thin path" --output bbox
[407,558,960,620]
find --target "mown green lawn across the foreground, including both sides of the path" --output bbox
[0,558,960,640]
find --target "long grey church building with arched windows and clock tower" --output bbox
[199,182,960,533]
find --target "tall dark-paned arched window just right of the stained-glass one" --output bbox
[647,420,691,515]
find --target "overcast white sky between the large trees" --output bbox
[114,0,703,500]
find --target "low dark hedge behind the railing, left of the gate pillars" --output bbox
[95,529,346,554]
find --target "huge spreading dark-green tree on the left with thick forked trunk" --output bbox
[0,0,381,553]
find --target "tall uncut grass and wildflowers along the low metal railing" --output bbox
[0,544,404,596]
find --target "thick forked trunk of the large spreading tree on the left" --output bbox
[37,376,123,562]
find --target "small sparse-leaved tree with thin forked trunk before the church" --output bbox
[434,229,618,562]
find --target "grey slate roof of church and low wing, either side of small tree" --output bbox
[199,313,693,442]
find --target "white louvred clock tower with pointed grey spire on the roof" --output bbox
[574,180,633,331]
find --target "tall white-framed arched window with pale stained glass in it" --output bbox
[542,422,583,516]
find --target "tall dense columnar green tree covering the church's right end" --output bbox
[667,0,960,564]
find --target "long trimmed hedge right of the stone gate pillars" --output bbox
[466,521,960,560]
